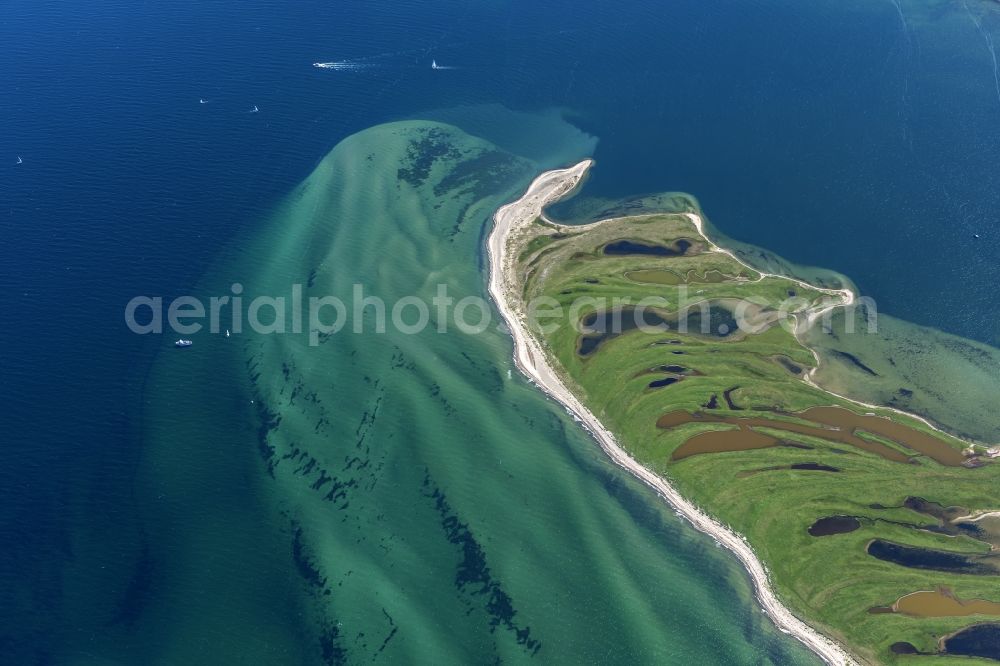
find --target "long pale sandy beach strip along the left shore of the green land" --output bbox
[487,160,858,665]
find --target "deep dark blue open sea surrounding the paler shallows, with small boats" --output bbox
[0,0,1000,663]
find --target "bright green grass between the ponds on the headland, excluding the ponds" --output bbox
[515,215,1000,664]
